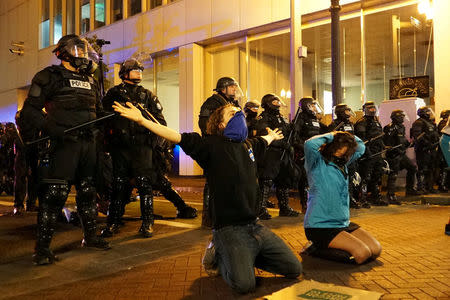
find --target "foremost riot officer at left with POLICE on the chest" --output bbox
[22,34,110,265]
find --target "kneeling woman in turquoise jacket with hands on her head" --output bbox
[304,131,381,264]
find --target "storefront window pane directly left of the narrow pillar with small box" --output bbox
[248,33,291,118]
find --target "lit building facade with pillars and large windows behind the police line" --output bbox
[0,0,450,175]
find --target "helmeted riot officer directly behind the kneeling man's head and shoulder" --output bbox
[198,77,242,227]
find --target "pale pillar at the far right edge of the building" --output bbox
[433,0,450,118]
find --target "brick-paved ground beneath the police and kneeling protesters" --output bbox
[0,178,450,299]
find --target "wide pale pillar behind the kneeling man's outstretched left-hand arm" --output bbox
[179,44,205,175]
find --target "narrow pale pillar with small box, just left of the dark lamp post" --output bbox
[290,0,303,118]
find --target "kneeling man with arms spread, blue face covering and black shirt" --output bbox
[115,103,302,293]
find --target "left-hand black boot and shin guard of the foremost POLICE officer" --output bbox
[33,204,59,265]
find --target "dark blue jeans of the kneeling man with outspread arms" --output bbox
[213,223,302,293]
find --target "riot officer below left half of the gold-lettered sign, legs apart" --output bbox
[383,109,418,205]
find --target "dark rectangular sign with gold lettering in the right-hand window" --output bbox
[389,76,430,99]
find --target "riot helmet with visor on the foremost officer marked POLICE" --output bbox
[52,34,99,74]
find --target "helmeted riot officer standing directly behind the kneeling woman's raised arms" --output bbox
[328,103,370,208]
